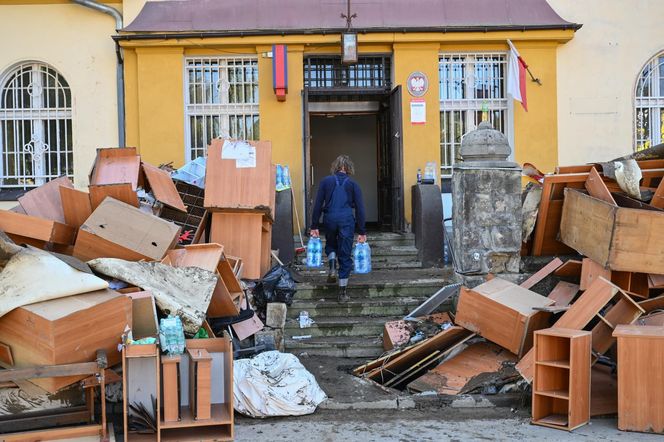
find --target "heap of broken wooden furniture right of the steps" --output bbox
[355,150,664,433]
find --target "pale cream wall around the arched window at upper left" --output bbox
[0,2,120,187]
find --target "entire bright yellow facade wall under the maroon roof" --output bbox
[122,31,574,226]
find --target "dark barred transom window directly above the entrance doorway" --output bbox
[304,55,391,91]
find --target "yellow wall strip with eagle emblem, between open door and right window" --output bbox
[393,43,440,223]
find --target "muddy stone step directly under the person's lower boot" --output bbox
[287,295,427,320]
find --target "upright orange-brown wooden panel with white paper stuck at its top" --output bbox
[205,139,275,214]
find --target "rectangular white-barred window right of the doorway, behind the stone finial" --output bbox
[438,53,512,178]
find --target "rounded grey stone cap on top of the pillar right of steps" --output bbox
[461,121,518,167]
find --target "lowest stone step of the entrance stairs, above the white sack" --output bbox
[284,329,383,358]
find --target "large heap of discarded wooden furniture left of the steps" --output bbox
[0,140,312,440]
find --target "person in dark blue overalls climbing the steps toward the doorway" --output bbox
[310,155,367,302]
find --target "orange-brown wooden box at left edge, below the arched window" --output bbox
[0,210,76,247]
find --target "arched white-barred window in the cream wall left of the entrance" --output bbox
[0,62,74,189]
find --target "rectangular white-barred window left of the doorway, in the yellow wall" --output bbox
[184,56,259,161]
